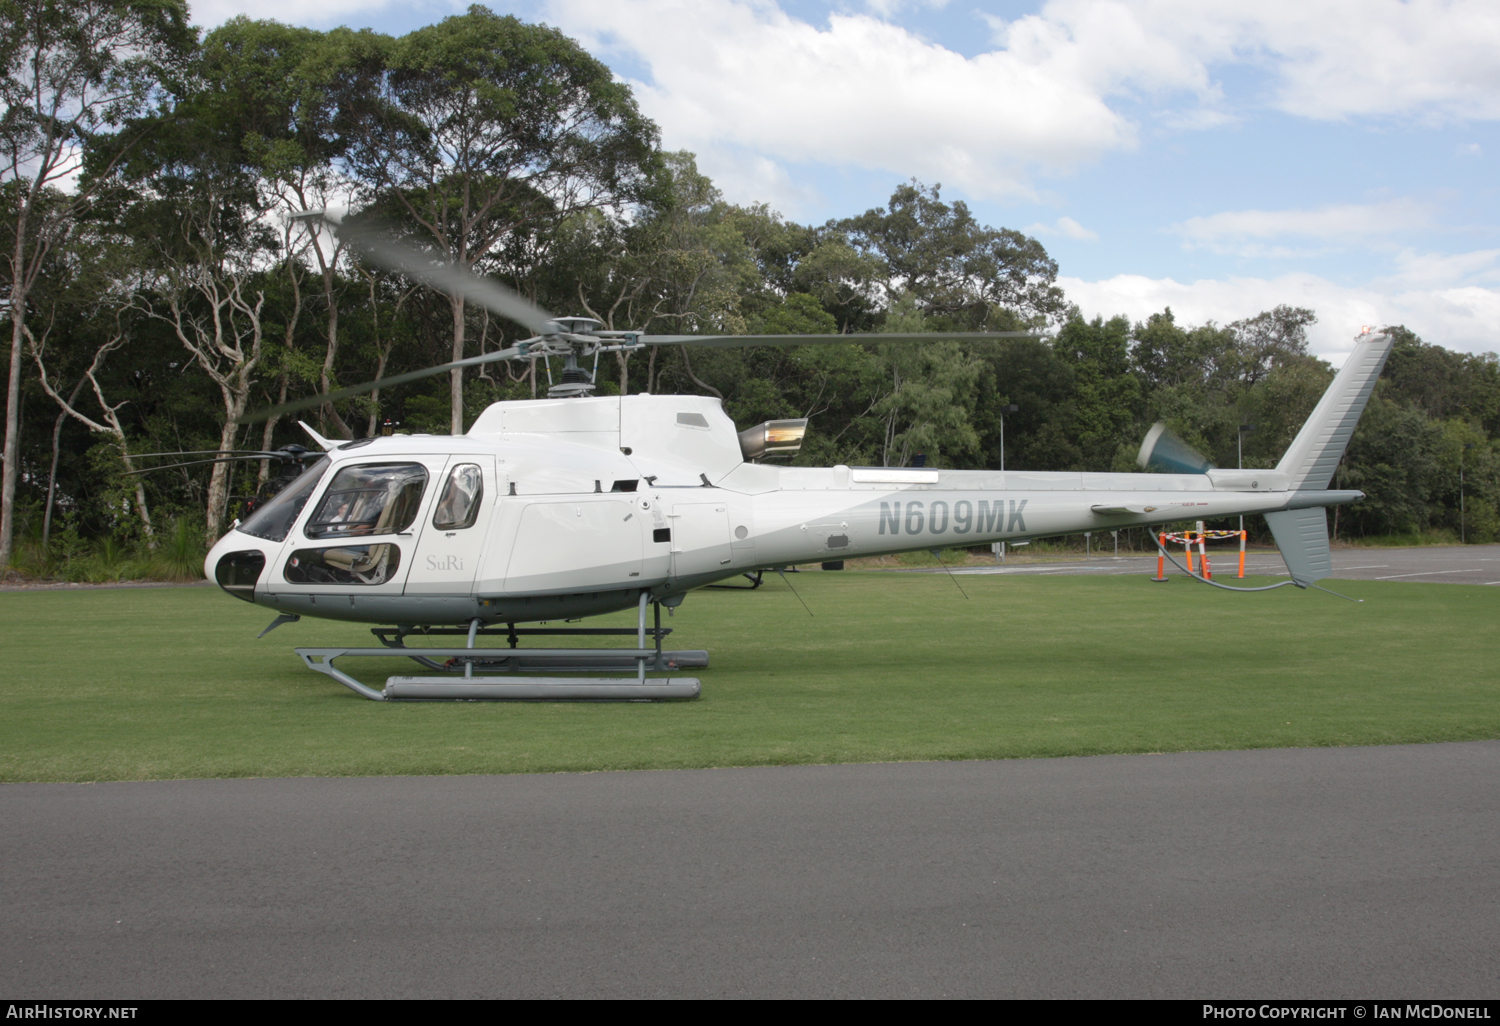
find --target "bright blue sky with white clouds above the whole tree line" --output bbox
[192,0,1500,363]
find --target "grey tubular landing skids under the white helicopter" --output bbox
[296,596,708,702]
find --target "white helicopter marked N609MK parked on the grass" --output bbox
[204,216,1392,701]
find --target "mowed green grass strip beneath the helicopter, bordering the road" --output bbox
[0,572,1500,782]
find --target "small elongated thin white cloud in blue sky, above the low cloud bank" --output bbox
[1167,200,1434,257]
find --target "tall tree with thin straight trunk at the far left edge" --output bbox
[0,0,195,569]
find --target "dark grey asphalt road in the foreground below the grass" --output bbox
[0,743,1500,999]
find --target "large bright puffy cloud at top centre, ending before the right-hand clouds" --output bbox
[549,0,1152,200]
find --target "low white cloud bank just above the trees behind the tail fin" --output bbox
[1058,268,1500,363]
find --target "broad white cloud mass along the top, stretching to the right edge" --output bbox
[545,0,1500,210]
